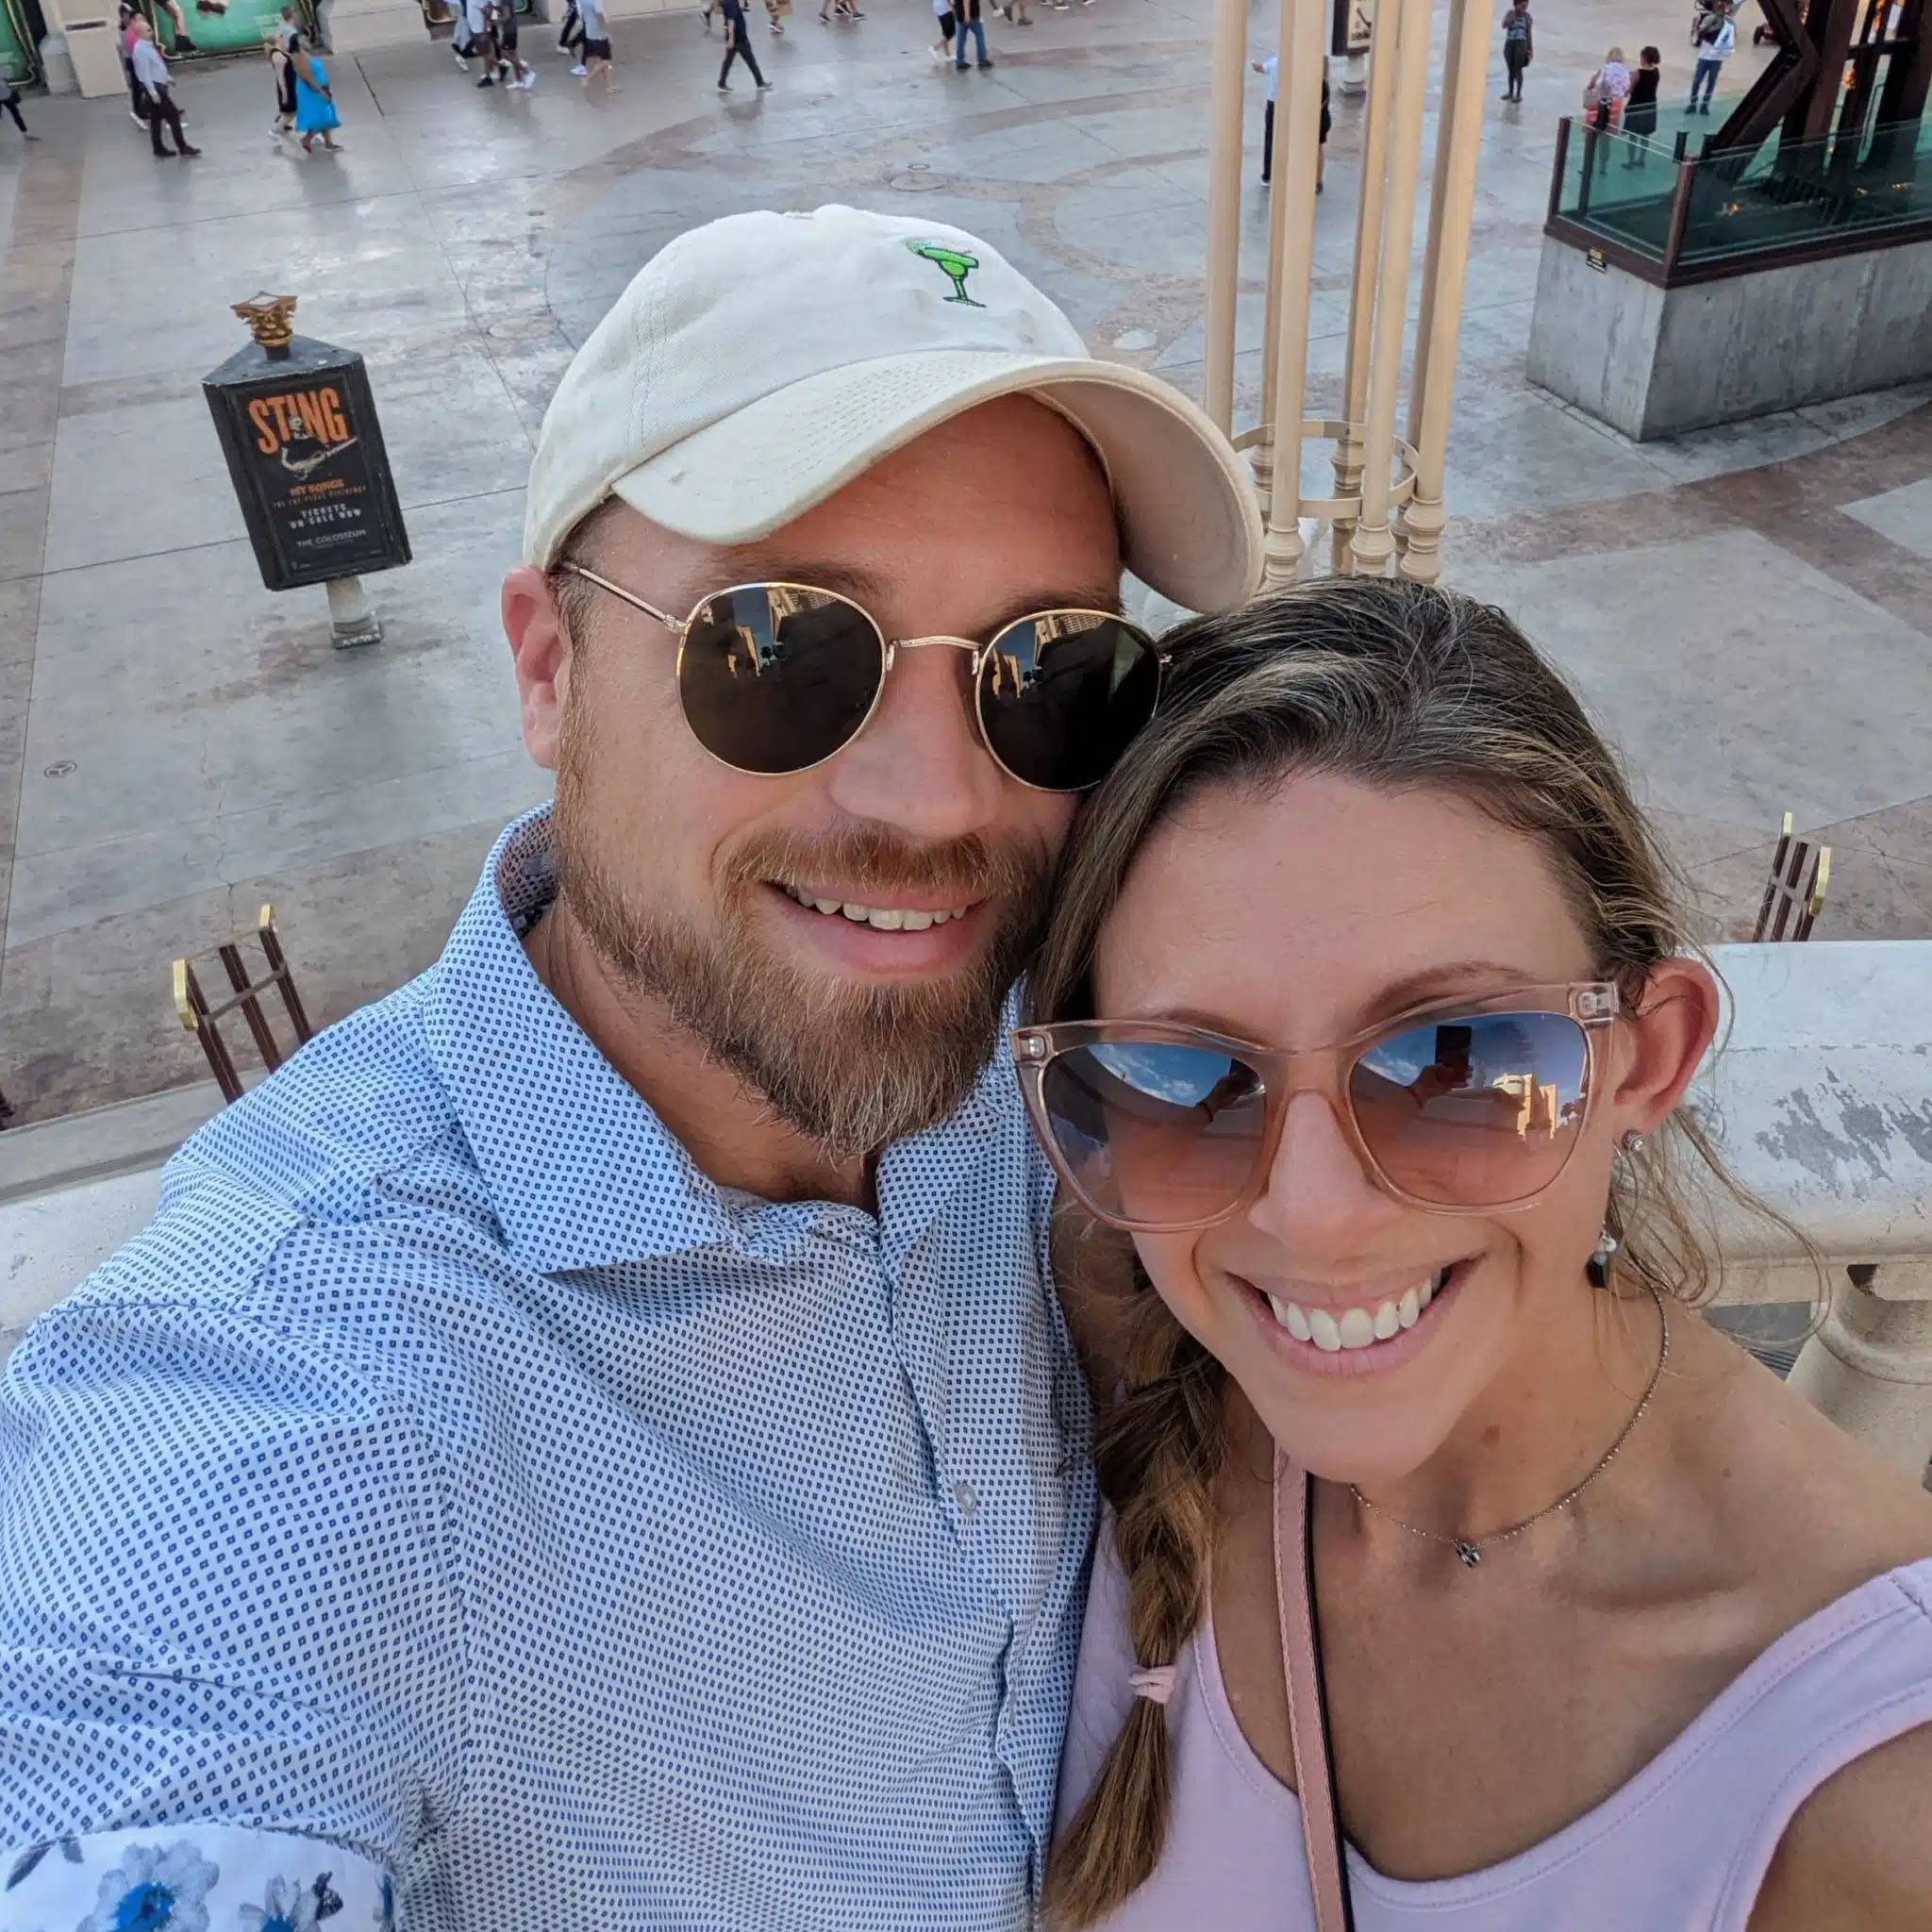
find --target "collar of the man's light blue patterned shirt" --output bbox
[424,808,1018,1274]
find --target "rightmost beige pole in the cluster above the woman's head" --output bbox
[1397,0,1493,583]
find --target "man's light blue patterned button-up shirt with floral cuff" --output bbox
[0,811,1093,1932]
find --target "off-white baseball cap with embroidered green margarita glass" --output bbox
[524,207,1261,610]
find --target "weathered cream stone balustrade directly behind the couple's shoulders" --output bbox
[0,939,1932,1474]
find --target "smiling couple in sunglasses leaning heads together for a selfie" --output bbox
[0,207,1932,1932]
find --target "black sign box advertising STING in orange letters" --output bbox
[201,336,409,591]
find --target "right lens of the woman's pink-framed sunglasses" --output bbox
[1349,1012,1591,1208]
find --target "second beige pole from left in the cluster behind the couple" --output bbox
[1261,0,1327,588]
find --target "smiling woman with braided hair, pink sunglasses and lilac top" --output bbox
[1016,579,1932,1932]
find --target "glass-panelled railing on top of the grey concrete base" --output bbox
[1545,118,1932,288]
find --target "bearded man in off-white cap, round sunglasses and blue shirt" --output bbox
[0,208,1259,1932]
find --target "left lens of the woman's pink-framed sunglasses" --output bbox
[1041,1041,1265,1226]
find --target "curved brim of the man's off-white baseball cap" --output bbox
[612,350,1261,610]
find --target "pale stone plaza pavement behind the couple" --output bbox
[0,0,1932,1119]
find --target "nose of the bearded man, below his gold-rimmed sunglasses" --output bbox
[827,643,1014,839]
